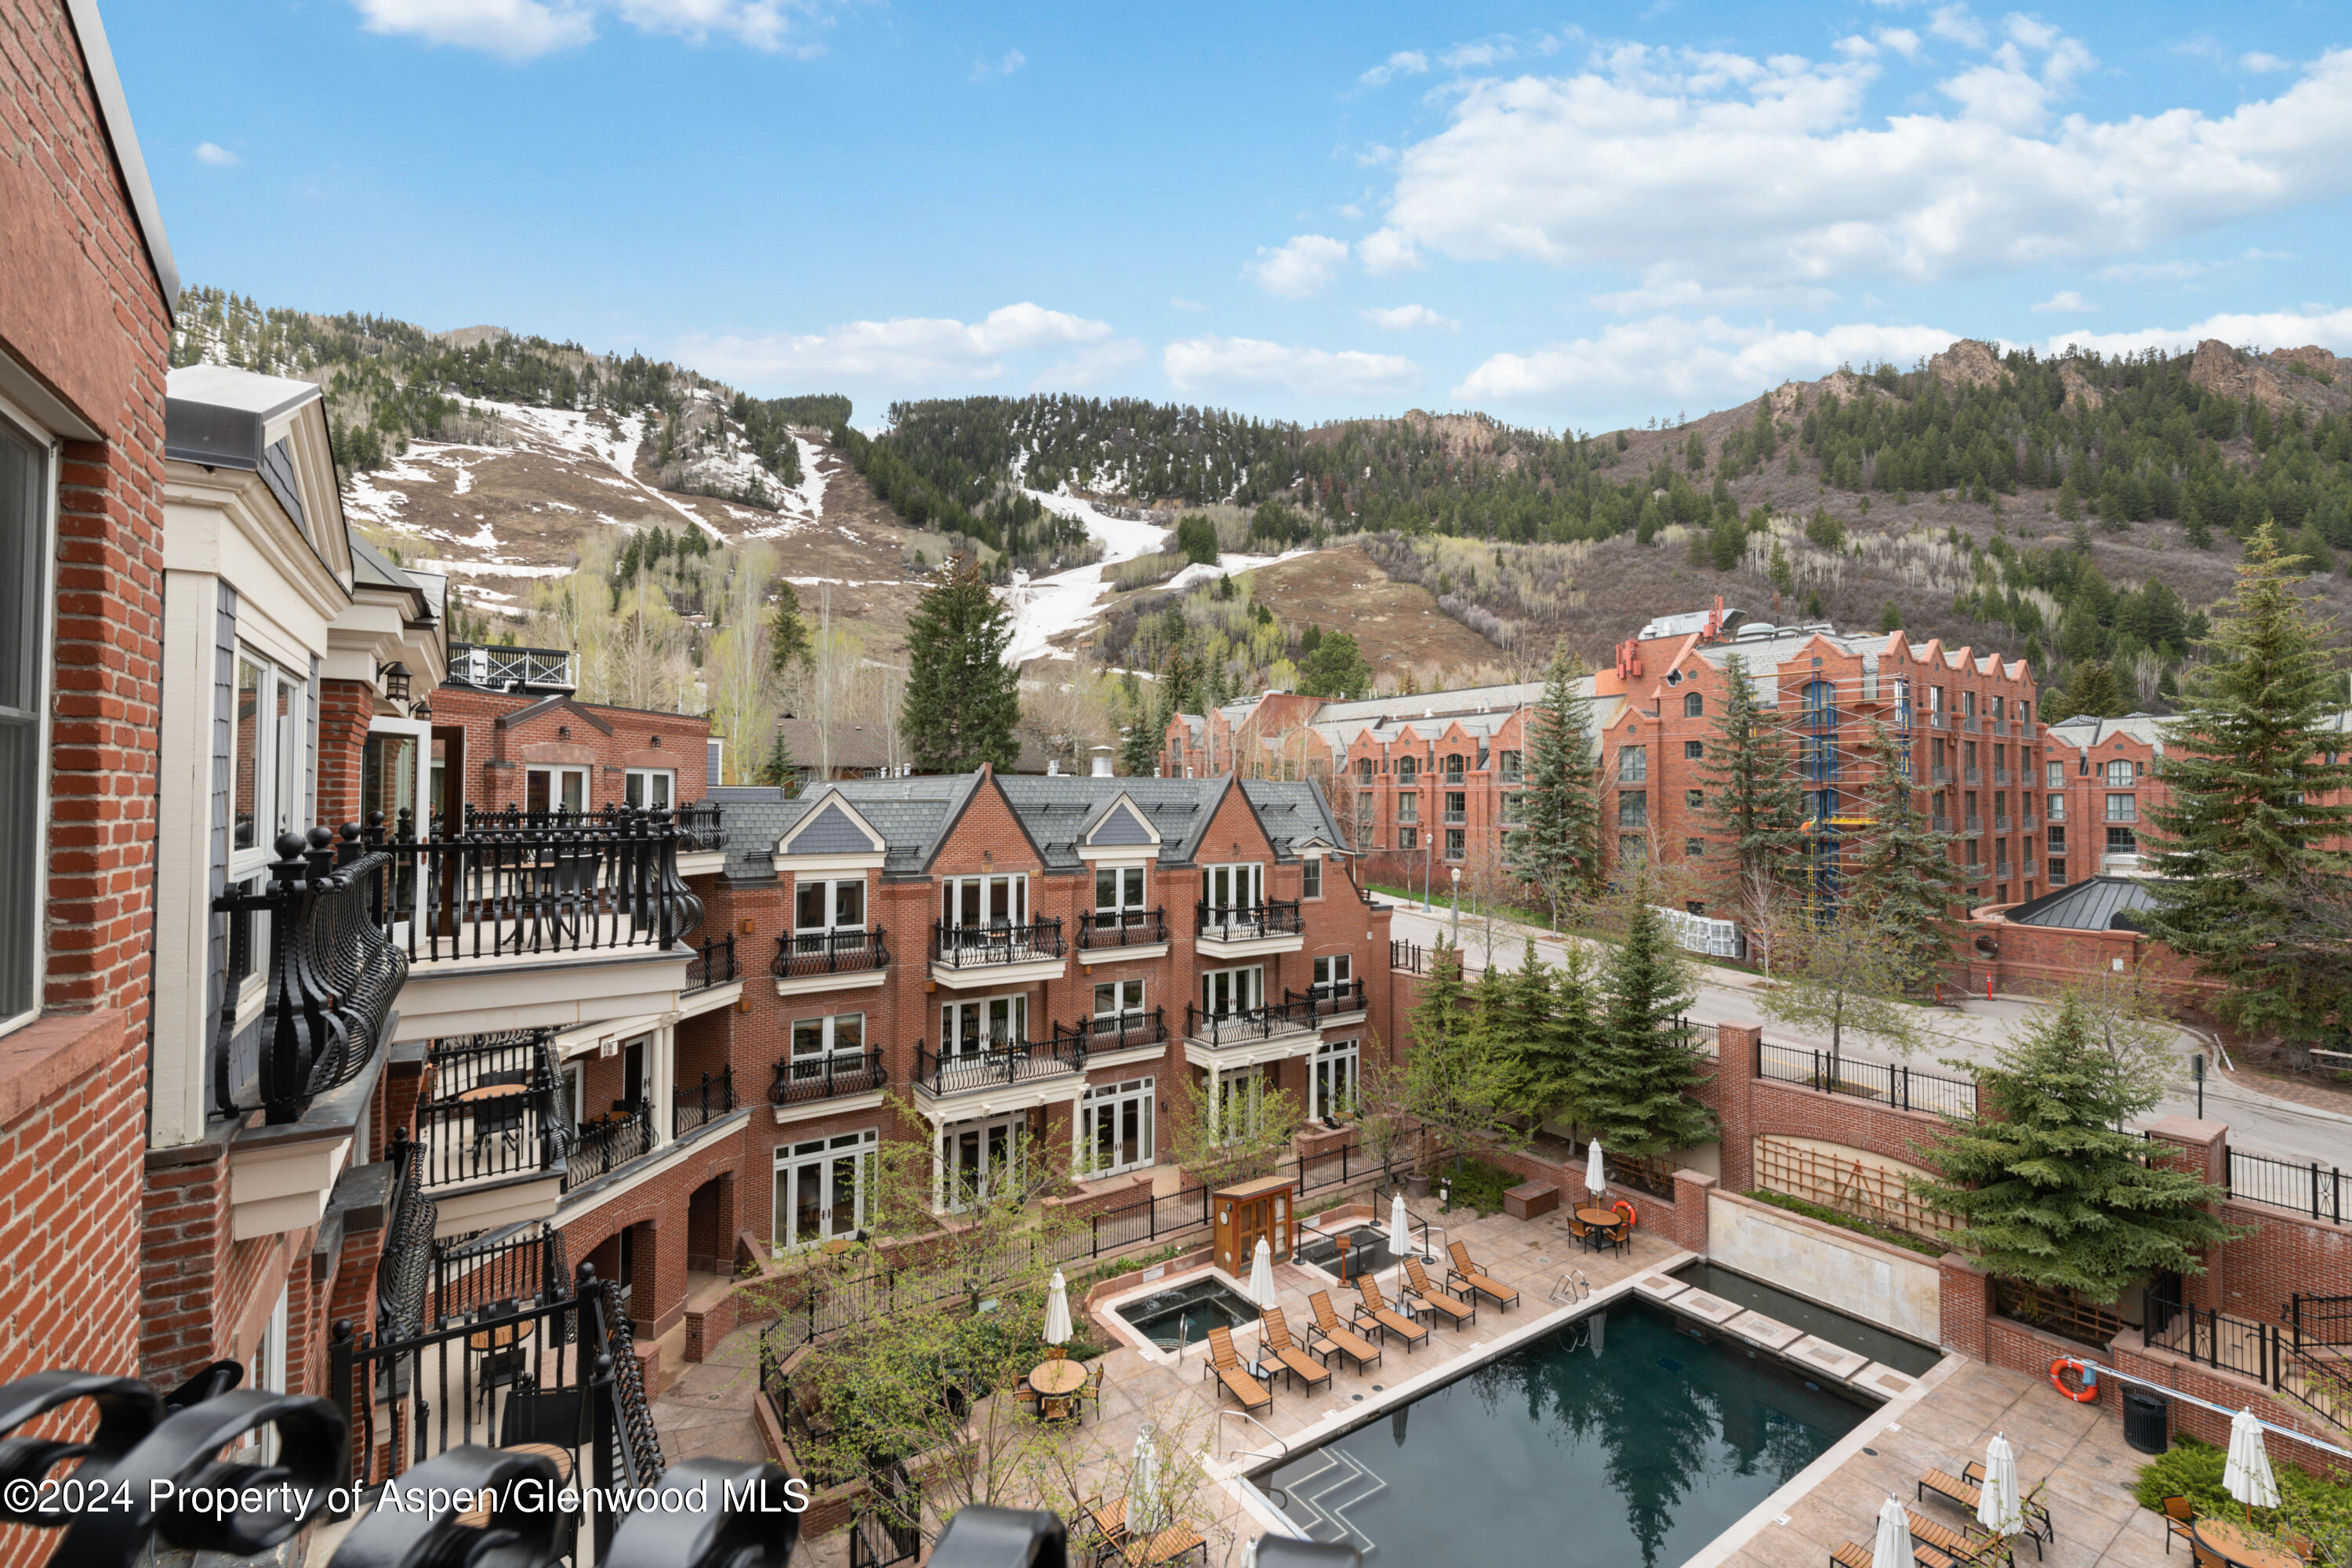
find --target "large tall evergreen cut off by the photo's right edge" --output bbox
[2145,524,2352,1039]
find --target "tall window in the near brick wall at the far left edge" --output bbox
[0,405,56,1029]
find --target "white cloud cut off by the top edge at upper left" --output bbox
[353,0,830,61]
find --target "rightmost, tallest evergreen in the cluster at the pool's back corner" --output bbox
[1571,888,1715,1159]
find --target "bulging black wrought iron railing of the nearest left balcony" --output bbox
[212,825,409,1123]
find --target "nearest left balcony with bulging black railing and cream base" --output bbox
[209,827,409,1241]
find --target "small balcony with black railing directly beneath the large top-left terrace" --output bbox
[416,1029,572,1236]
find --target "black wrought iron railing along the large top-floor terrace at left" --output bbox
[369,806,703,964]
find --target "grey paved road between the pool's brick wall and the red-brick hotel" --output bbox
[1392,902,2352,1166]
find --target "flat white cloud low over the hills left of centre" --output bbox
[675,303,1110,386]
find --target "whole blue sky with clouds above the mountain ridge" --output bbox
[103,0,2352,430]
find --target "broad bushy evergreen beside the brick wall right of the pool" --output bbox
[1912,996,2232,1302]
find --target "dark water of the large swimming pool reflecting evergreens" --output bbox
[1258,1298,1872,1568]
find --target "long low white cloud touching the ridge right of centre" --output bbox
[1454,315,1959,407]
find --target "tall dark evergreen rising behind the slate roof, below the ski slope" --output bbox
[898,555,1021,774]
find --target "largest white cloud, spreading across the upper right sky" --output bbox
[1357,42,2352,287]
